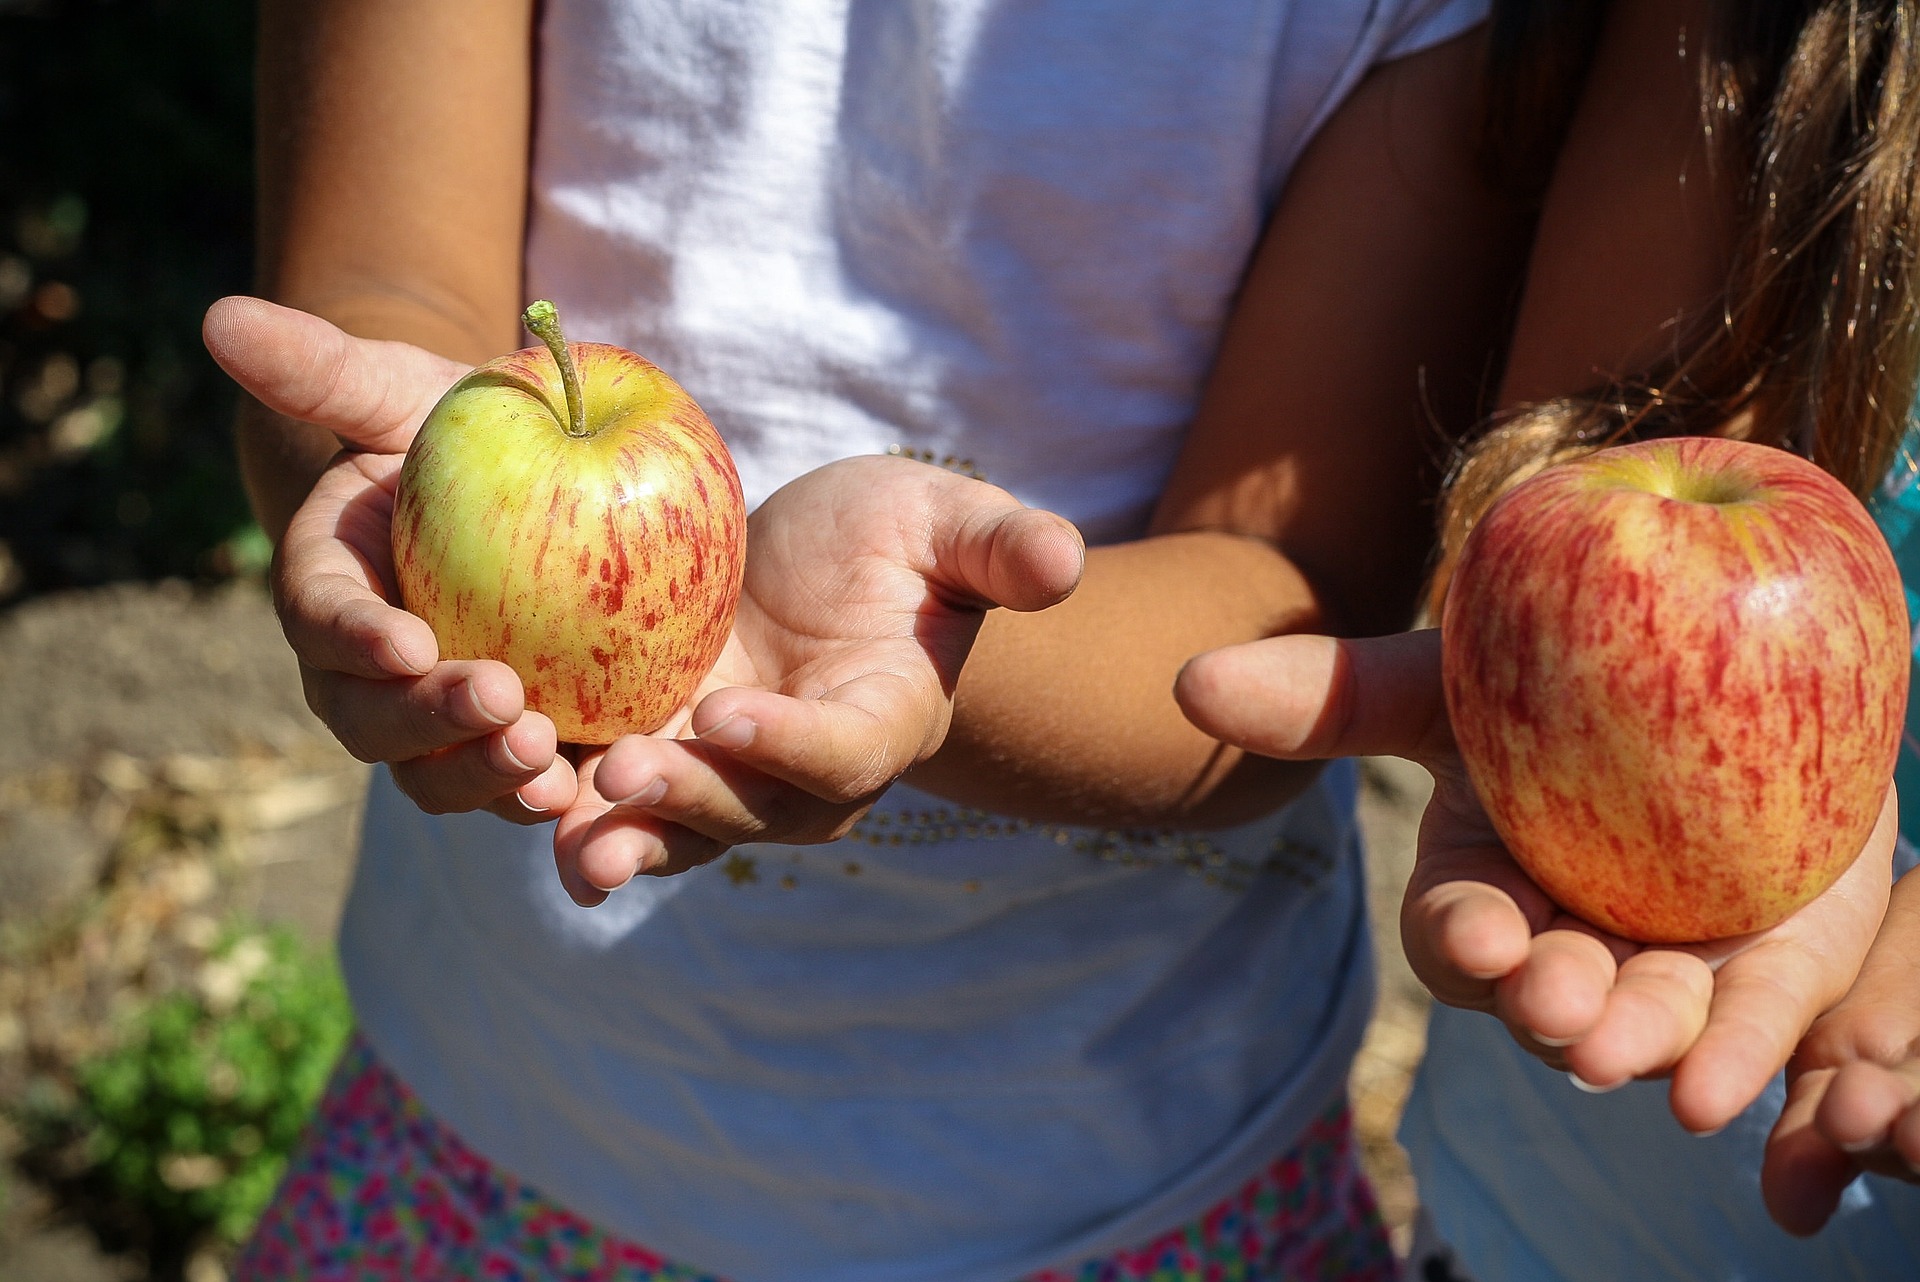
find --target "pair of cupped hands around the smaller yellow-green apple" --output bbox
[216,297,1085,904]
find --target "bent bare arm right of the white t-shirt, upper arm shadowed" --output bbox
[914,27,1530,827]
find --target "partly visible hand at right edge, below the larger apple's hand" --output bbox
[1761,859,1920,1234]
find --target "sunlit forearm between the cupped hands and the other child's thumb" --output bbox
[908,532,1323,827]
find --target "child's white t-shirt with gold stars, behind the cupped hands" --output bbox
[342,0,1484,1282]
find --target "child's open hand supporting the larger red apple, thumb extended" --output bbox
[1175,631,1895,1132]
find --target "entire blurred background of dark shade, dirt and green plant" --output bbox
[0,0,1427,1282]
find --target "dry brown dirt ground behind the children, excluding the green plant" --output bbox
[0,583,1427,1282]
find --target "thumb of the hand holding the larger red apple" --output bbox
[1173,629,1453,768]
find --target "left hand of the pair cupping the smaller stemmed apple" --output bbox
[205,297,576,823]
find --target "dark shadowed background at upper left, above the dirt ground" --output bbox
[0,0,259,601]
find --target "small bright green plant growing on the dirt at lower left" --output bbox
[17,929,351,1276]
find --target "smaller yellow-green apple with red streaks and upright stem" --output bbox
[394,301,747,745]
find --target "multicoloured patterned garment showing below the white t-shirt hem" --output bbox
[236,1038,1394,1282]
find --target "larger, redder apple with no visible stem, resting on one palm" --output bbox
[1442,438,1910,942]
